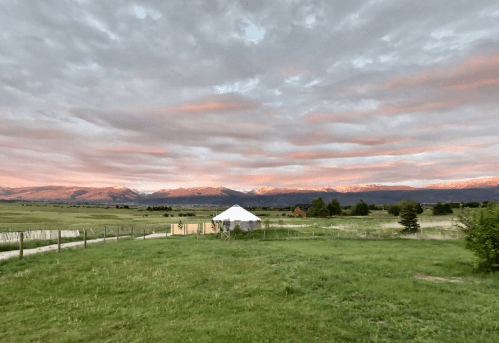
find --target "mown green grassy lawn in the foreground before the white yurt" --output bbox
[0,236,499,342]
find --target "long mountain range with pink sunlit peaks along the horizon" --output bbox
[0,177,499,206]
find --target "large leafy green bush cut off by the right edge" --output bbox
[458,204,499,272]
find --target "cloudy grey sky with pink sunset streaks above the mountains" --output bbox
[0,0,499,191]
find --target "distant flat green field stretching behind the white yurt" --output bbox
[0,203,460,235]
